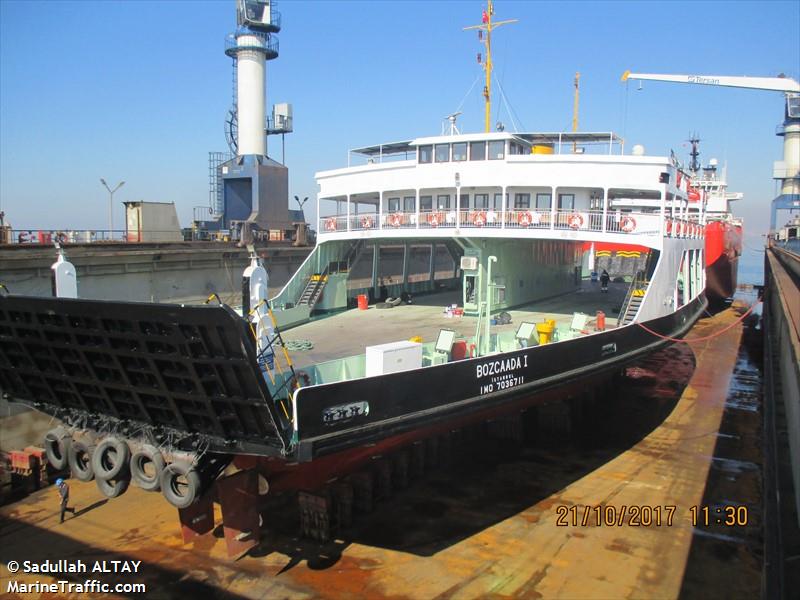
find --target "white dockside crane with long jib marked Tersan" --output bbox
[622,71,800,233]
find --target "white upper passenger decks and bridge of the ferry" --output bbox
[316,132,703,246]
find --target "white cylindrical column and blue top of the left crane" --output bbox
[225,0,281,156]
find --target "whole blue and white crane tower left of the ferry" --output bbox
[212,0,294,239]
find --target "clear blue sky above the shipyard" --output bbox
[0,0,800,255]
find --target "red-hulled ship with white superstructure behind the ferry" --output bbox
[689,136,743,304]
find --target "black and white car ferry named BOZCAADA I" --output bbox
[0,6,707,521]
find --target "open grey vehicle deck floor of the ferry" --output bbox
[282,281,629,368]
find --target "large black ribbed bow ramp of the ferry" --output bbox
[0,296,292,456]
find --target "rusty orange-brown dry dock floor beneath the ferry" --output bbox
[0,306,761,598]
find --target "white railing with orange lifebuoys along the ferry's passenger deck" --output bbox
[319,208,704,238]
